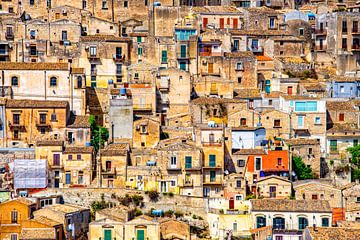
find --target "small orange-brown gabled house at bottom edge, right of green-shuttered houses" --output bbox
[160,219,190,240]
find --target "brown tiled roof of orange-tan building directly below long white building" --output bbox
[6,99,69,108]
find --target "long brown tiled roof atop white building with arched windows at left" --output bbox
[0,62,69,71]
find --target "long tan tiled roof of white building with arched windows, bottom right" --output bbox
[251,199,332,213]
